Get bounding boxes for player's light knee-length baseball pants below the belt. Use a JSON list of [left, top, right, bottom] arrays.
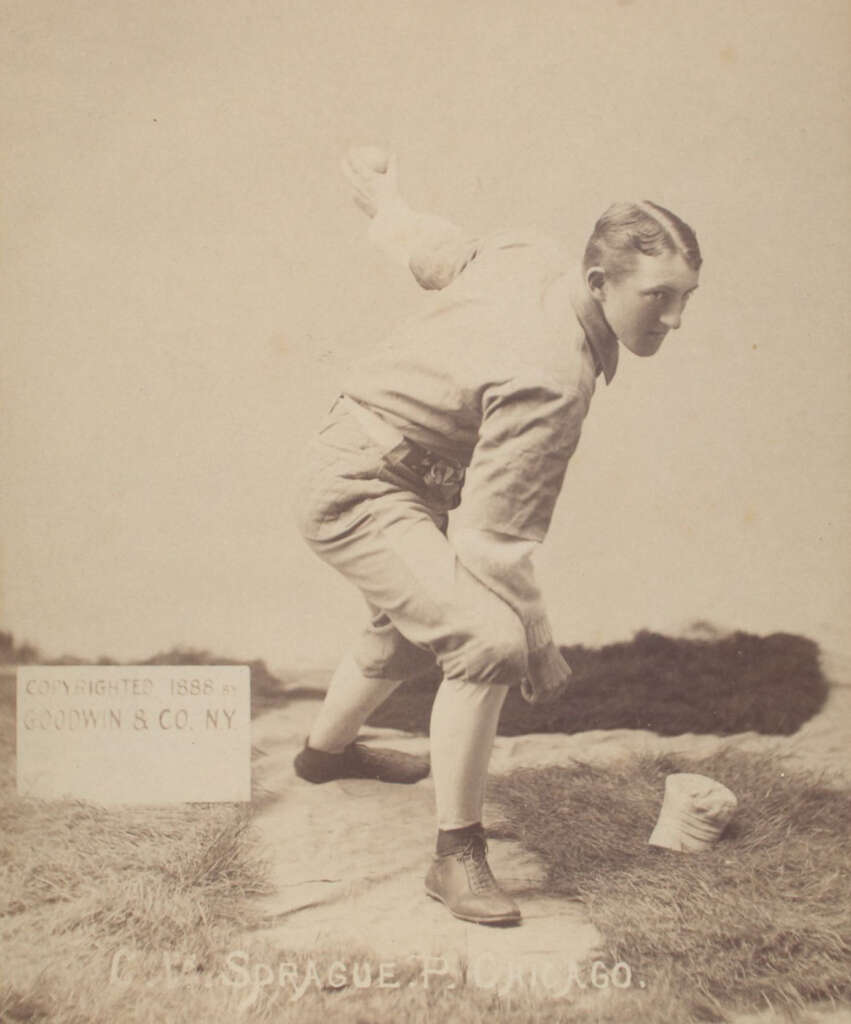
[[294, 402, 526, 686]]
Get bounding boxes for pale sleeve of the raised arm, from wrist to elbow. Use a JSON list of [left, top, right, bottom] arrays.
[[368, 199, 476, 290]]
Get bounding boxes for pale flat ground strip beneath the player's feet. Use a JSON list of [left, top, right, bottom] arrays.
[[242, 701, 600, 992]]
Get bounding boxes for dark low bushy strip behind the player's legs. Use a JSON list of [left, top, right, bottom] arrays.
[[370, 631, 827, 736]]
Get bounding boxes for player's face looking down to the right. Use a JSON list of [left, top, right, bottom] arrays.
[[588, 252, 699, 355]]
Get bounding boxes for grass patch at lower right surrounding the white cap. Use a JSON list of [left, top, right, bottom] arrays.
[[491, 752, 851, 1020]]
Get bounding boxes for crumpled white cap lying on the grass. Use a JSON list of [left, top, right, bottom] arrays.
[[647, 772, 738, 853]]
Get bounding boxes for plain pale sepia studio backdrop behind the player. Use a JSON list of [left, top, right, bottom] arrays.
[[0, 0, 851, 667]]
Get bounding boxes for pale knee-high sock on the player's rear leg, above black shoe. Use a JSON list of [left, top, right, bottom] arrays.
[[307, 654, 399, 754]]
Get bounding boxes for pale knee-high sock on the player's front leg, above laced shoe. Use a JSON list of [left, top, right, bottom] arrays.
[[431, 679, 508, 829]]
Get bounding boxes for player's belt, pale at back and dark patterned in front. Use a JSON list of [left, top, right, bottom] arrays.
[[337, 394, 466, 508]]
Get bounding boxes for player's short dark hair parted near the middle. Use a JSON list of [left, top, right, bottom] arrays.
[[583, 200, 703, 279]]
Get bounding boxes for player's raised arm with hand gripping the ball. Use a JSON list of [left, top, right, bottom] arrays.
[[342, 146, 476, 290]]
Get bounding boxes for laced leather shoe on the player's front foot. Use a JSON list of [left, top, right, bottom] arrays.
[[425, 835, 520, 925]]
